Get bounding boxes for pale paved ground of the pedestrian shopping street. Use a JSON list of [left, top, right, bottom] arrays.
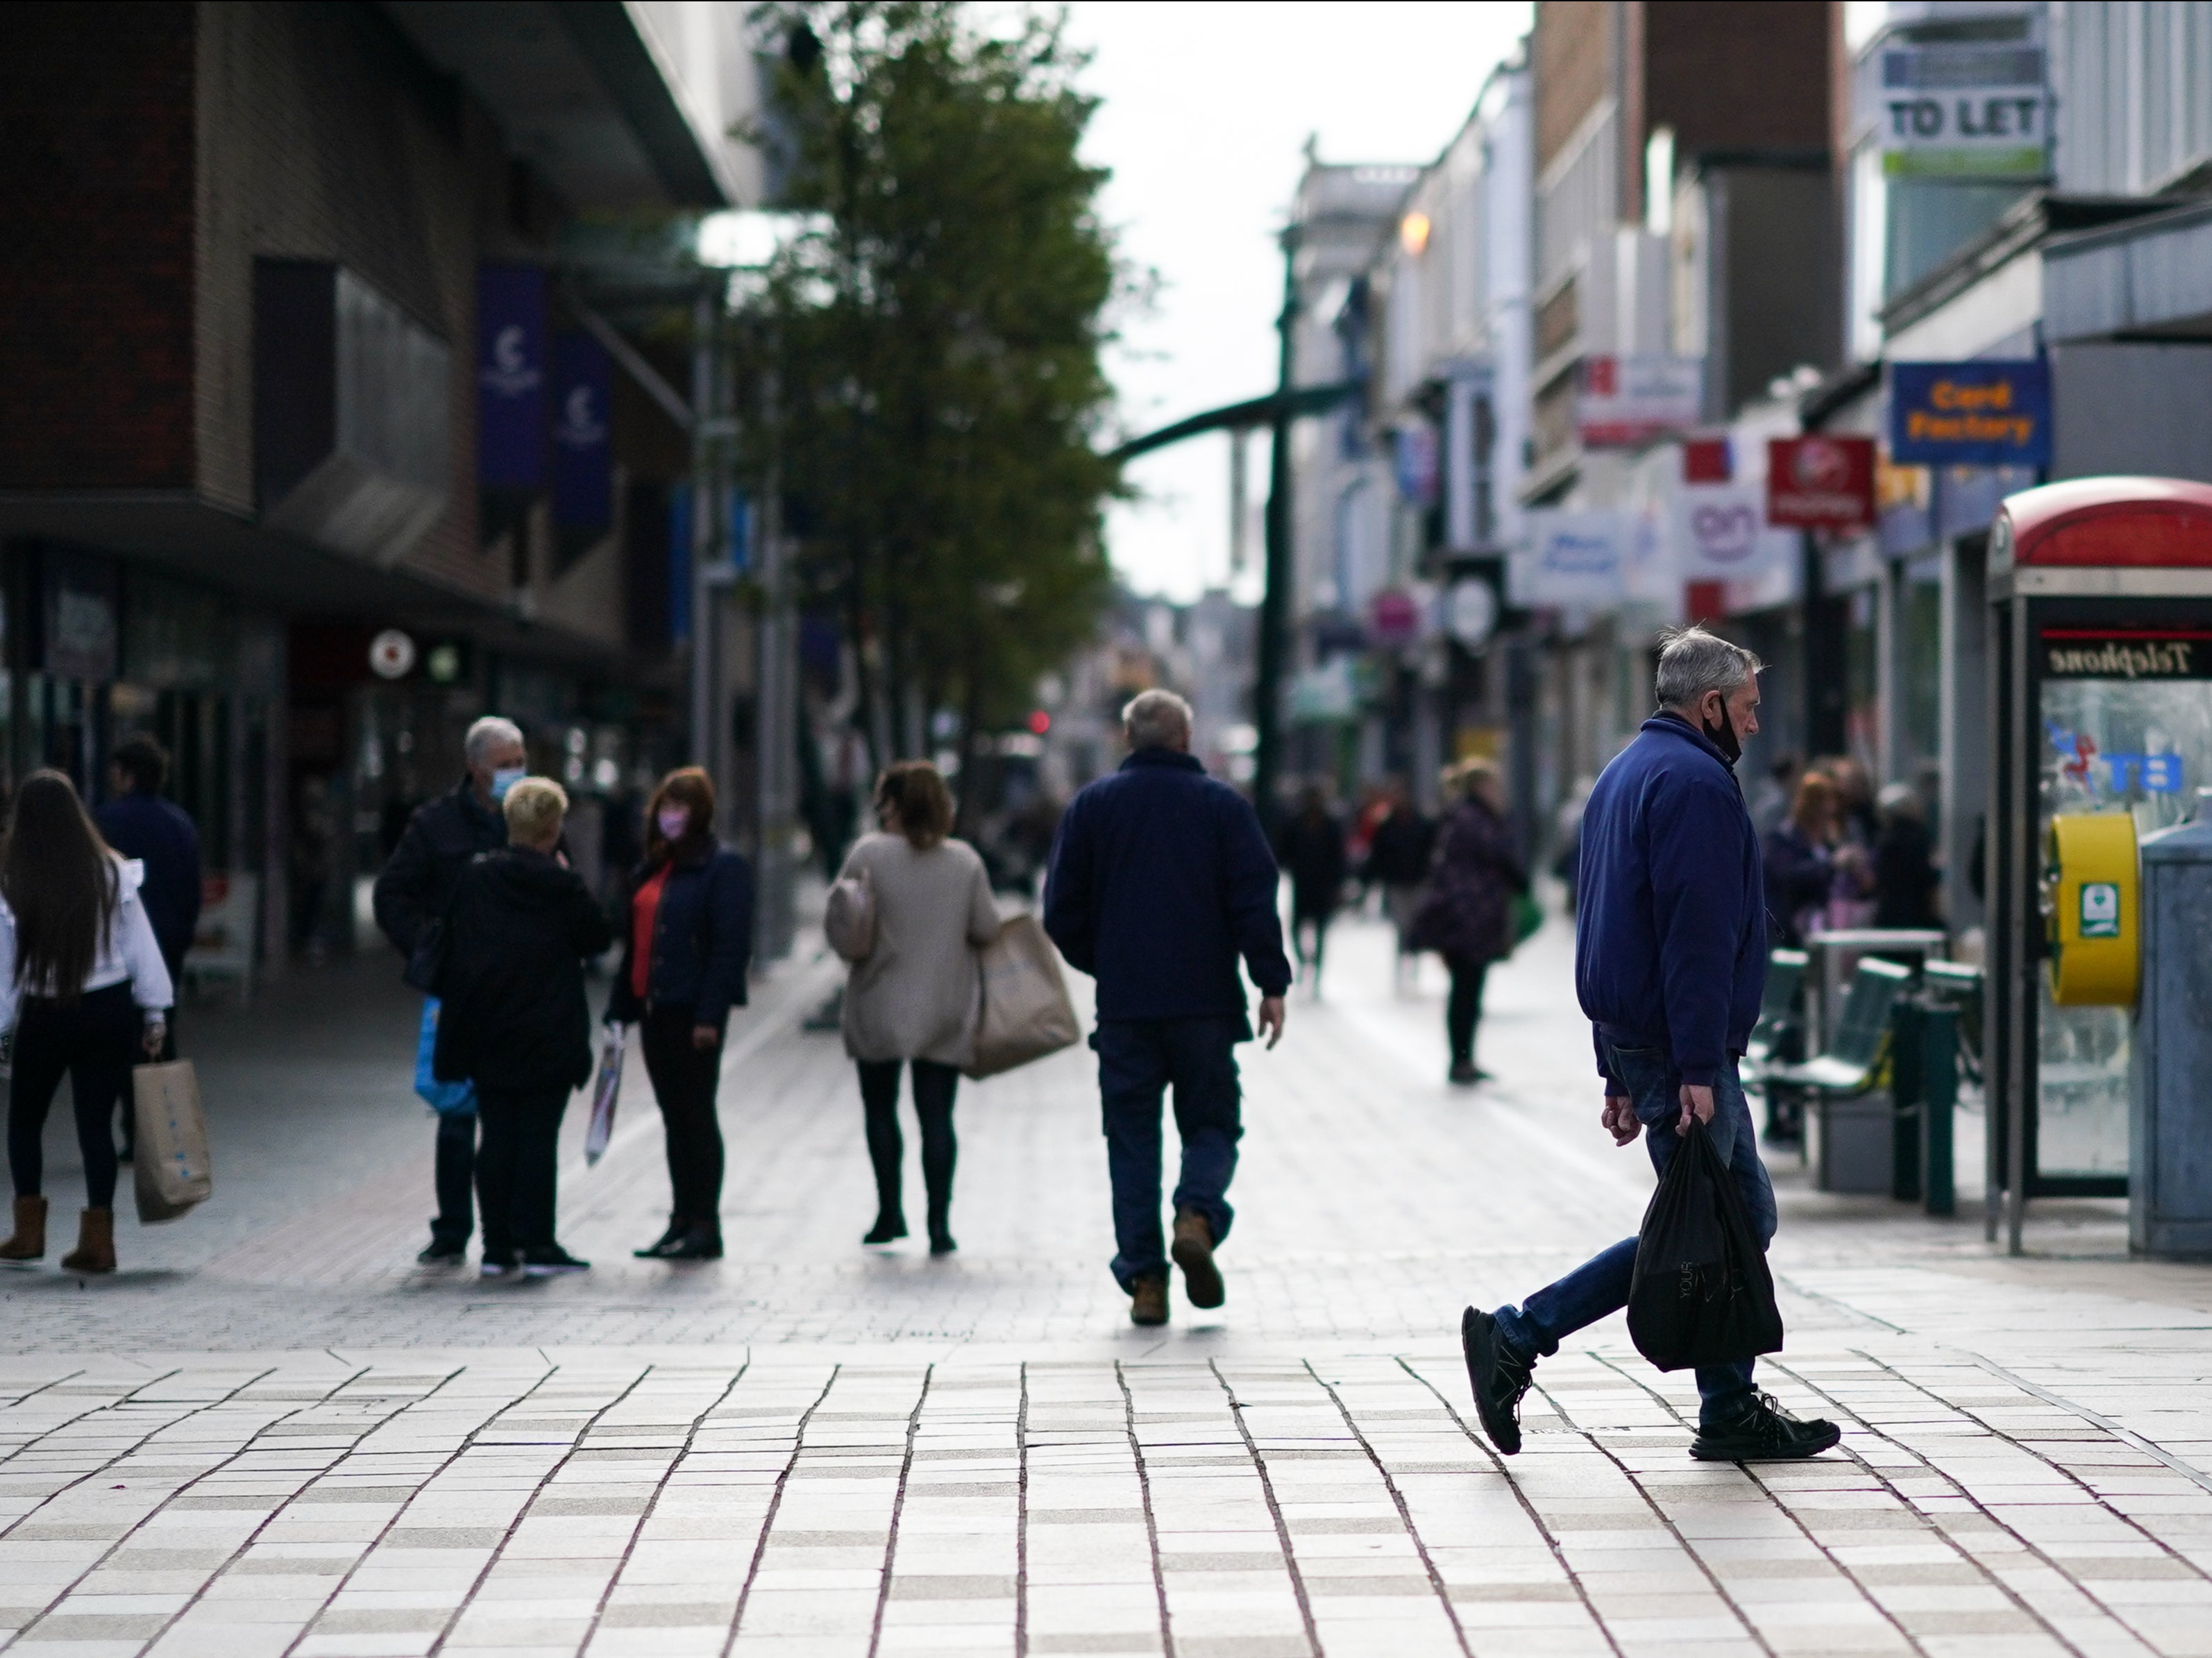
[[0, 922, 2212, 1658]]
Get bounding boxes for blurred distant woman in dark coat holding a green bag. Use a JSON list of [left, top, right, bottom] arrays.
[[1413, 761, 1528, 1088]]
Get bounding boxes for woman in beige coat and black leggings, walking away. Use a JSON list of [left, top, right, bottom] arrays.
[[841, 761, 997, 1255]]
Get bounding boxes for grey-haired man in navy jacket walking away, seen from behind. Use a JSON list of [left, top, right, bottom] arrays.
[[1044, 690, 1290, 1324]]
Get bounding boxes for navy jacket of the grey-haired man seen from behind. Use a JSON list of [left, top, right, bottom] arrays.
[[1044, 747, 1290, 1035]]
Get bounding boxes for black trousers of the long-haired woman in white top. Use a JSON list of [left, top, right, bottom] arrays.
[[7, 981, 144, 1209]]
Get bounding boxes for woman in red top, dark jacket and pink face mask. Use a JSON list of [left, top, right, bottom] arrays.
[[606, 765, 752, 1260]]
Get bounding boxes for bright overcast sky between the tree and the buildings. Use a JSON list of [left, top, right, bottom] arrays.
[[1068, 0, 1882, 599]]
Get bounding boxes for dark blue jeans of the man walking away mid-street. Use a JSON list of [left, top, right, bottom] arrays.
[[1090, 1019, 1252, 1289]]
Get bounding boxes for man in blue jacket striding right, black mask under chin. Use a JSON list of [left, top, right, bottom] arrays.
[[1460, 628, 1841, 1462]]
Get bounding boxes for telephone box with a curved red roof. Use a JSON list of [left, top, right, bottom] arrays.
[[1984, 477, 2212, 1253]]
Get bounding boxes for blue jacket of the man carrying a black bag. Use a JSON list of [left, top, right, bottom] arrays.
[[1575, 714, 1767, 1092]]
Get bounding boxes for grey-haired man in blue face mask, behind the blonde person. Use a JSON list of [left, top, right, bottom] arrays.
[[376, 714, 529, 1264]]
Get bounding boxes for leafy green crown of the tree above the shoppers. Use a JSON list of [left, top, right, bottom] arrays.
[[743, 0, 1128, 807]]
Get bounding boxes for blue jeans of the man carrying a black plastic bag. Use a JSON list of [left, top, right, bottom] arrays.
[[1498, 1037, 1774, 1428]]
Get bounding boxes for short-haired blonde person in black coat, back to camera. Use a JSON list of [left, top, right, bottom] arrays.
[[431, 778, 613, 1278]]
